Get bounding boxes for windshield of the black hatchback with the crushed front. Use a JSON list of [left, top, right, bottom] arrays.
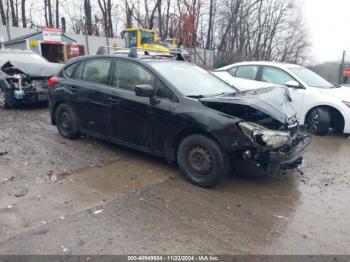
[[150, 62, 236, 97]]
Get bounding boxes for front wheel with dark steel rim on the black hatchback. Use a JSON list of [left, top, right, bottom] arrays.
[[177, 135, 229, 188]]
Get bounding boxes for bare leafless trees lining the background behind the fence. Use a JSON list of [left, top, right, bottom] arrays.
[[0, 0, 309, 63]]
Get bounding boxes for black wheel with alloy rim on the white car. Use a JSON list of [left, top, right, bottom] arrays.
[[306, 107, 331, 136]]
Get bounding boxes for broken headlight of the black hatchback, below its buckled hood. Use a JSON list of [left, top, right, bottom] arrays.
[[239, 122, 292, 149]]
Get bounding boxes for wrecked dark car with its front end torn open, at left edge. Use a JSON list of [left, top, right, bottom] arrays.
[[0, 50, 63, 109]]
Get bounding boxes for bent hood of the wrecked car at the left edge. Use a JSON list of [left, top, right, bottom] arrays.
[[1, 61, 63, 77]]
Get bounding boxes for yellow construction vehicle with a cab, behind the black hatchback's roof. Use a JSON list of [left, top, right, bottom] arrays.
[[121, 28, 170, 53]]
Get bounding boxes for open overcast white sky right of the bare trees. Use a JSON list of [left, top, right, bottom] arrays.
[[304, 0, 350, 62]]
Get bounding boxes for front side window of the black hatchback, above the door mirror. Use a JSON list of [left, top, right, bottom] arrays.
[[113, 60, 154, 91]]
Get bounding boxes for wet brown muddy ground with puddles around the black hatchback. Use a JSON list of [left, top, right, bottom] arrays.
[[0, 107, 350, 254]]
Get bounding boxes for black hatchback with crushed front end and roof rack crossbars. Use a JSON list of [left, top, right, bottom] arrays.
[[49, 55, 310, 187]]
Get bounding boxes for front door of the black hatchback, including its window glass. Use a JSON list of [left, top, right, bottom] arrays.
[[111, 59, 178, 151]]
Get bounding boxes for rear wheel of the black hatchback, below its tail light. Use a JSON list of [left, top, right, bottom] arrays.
[[55, 104, 80, 139]]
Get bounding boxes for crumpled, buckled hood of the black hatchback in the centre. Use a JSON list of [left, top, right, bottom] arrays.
[[200, 86, 296, 124]]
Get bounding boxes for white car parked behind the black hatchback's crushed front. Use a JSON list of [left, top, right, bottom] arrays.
[[213, 62, 350, 135]]
